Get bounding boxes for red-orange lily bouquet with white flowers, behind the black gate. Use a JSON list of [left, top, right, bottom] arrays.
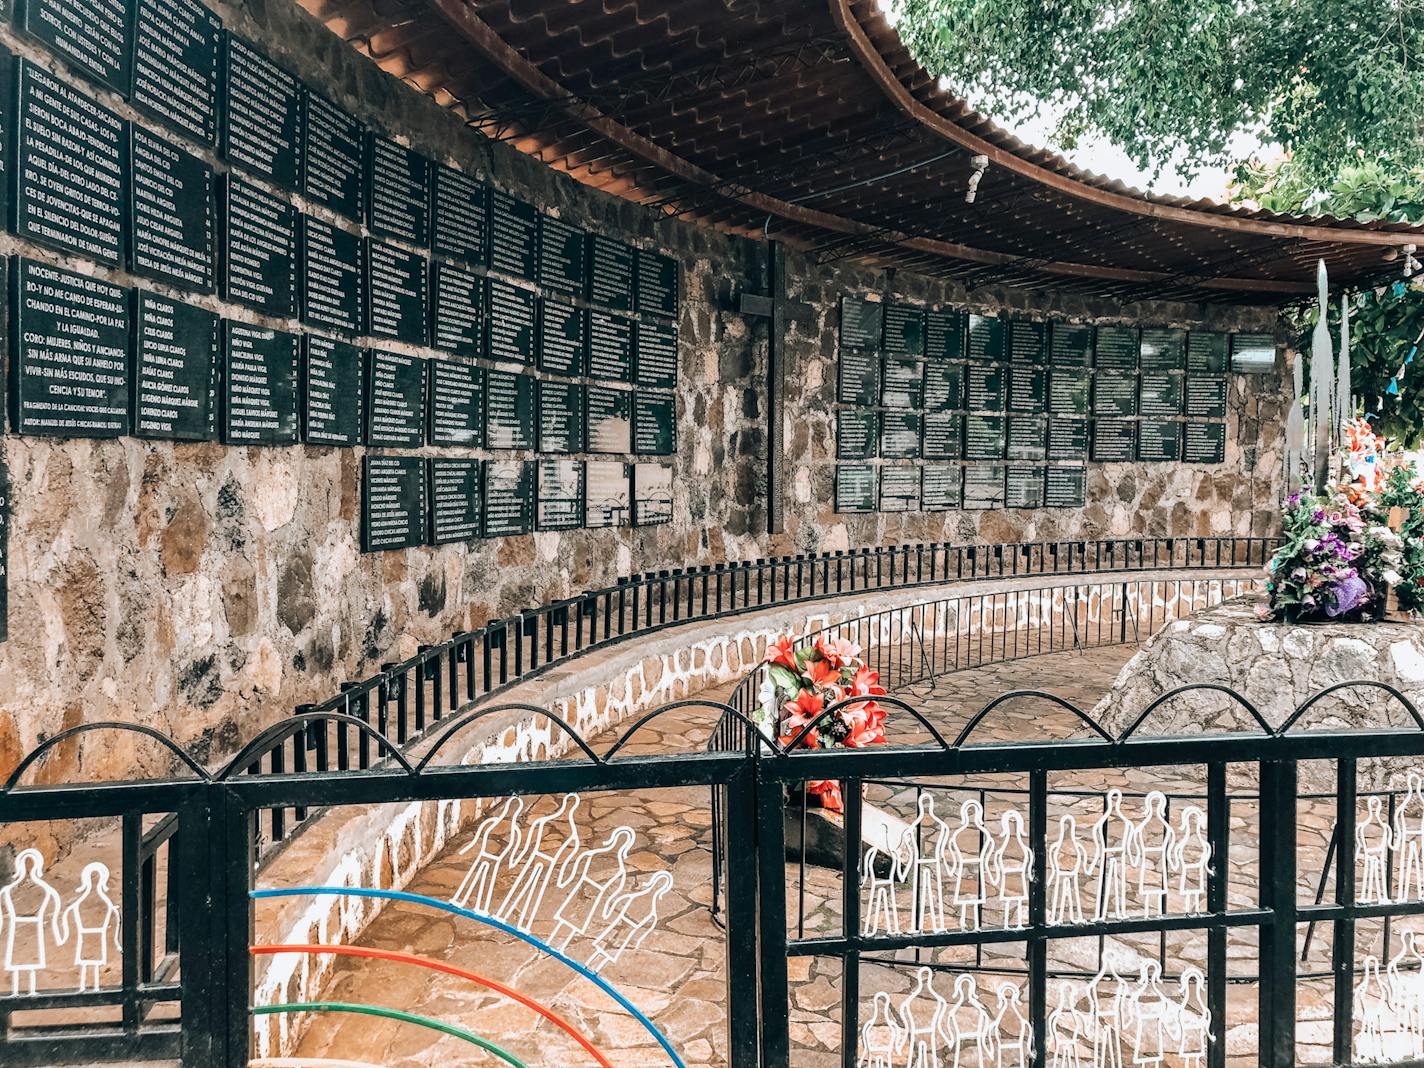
[[760, 634, 886, 812]]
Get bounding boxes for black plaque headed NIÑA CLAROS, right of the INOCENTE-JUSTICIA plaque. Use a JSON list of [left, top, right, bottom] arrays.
[[132, 290, 221, 441]]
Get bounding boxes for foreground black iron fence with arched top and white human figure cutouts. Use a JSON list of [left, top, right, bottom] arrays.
[[0, 684, 1424, 1068]]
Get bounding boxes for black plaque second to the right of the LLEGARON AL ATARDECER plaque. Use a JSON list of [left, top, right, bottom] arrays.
[[219, 174, 296, 319]]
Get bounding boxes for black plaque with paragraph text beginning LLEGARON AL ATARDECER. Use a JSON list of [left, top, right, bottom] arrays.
[[16, 60, 124, 265]]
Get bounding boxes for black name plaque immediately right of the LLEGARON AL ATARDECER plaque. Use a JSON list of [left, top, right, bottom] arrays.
[[128, 124, 216, 293]]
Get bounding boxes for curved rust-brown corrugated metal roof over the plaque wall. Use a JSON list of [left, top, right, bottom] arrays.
[[300, 0, 1424, 303]]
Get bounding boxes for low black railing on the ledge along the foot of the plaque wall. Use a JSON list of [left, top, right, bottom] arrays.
[[235, 537, 1277, 854]]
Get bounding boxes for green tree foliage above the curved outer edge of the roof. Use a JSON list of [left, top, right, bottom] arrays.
[[894, 0, 1424, 185]]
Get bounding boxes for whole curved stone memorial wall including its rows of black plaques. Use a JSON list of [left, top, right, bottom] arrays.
[[0, 0, 1283, 778]]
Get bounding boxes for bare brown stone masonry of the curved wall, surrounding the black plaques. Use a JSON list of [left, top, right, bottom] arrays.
[[0, 0, 1283, 797]]
